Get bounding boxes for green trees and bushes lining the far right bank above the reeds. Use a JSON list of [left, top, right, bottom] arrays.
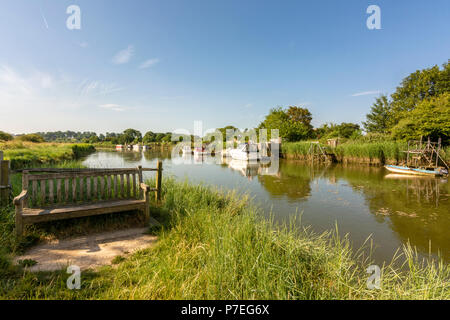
[[258, 62, 450, 143]]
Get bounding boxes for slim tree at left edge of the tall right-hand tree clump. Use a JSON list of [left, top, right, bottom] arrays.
[[363, 95, 392, 133]]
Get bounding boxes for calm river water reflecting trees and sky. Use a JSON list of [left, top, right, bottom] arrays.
[[84, 151, 450, 262]]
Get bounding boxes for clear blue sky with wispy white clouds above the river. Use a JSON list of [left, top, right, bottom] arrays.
[[0, 0, 450, 133]]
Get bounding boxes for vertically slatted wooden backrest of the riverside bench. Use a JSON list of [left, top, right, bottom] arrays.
[[22, 167, 143, 207]]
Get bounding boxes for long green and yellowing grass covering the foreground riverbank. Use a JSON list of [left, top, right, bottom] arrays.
[[0, 180, 450, 299]]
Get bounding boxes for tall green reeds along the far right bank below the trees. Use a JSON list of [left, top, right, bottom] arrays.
[[282, 140, 450, 165]]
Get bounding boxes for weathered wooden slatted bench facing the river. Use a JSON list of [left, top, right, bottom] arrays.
[[14, 161, 162, 236]]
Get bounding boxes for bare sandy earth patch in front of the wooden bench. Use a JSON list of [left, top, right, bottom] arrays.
[[14, 219, 157, 271]]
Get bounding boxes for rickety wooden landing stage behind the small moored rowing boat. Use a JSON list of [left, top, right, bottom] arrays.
[[403, 138, 449, 170]]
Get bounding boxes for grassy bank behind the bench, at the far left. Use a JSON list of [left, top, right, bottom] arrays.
[[0, 141, 95, 169]]
